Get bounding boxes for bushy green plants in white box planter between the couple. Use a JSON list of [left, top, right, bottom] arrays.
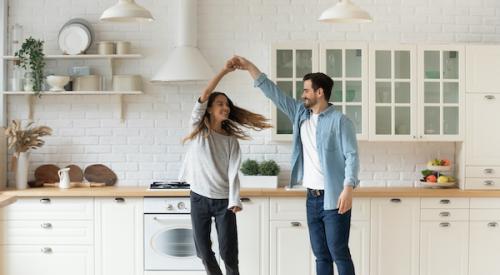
[[240, 159, 280, 188]]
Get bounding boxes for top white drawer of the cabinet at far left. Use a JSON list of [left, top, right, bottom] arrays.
[[0, 197, 94, 220]]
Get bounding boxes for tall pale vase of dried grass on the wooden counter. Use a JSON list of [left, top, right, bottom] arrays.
[[5, 120, 52, 189]]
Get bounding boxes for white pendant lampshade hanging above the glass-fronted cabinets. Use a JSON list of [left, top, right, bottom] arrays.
[[318, 0, 373, 23]]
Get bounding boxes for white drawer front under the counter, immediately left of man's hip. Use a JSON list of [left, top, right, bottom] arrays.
[[269, 198, 307, 220]]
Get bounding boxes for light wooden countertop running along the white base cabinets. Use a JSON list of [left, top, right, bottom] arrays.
[[0, 186, 500, 198]]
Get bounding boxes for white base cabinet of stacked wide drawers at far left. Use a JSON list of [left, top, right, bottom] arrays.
[[0, 197, 94, 275]]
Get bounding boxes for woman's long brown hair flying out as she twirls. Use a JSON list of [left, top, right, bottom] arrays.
[[182, 92, 272, 142]]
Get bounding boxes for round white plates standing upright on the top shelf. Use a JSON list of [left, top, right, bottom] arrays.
[[57, 18, 94, 55]]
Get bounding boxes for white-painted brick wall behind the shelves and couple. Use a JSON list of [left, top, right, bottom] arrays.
[[4, 0, 500, 186]]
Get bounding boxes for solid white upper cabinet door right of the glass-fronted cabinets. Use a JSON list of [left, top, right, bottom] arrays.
[[466, 45, 500, 93]]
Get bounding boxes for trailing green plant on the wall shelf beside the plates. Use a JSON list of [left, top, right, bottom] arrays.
[[15, 36, 45, 96]]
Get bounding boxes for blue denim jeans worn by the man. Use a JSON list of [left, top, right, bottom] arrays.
[[306, 189, 354, 275]]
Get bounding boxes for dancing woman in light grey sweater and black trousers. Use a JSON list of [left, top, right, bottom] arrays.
[[181, 61, 271, 275]]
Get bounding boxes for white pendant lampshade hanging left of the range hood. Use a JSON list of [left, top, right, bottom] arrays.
[[99, 0, 154, 22]]
